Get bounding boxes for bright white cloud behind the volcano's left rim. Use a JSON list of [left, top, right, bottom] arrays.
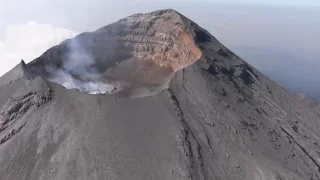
[[0, 21, 77, 76]]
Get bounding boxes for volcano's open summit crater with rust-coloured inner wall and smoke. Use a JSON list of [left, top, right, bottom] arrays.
[[29, 10, 202, 97]]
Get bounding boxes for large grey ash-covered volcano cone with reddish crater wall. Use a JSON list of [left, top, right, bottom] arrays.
[[0, 10, 320, 180]]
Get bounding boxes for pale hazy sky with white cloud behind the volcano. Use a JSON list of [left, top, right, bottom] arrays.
[[0, 0, 320, 98]]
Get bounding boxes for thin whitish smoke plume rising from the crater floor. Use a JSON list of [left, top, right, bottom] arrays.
[[46, 35, 118, 94]]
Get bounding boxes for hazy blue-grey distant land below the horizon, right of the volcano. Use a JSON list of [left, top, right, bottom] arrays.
[[231, 46, 320, 101]]
